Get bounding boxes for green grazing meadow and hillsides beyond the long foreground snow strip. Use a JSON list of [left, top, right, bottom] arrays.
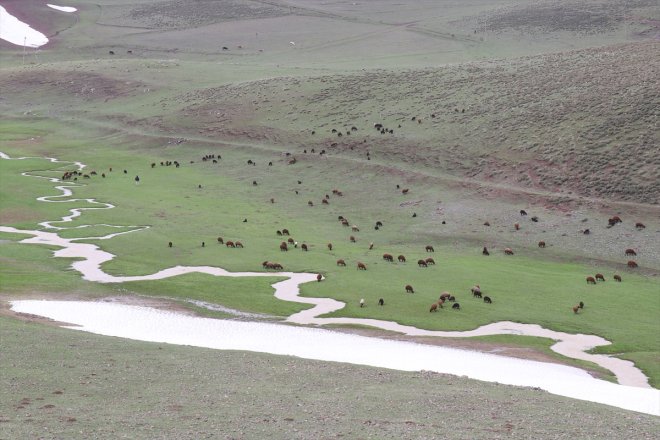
[[0, 0, 660, 438]]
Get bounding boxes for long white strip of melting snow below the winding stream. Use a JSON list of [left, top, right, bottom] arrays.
[[11, 300, 660, 415]]
